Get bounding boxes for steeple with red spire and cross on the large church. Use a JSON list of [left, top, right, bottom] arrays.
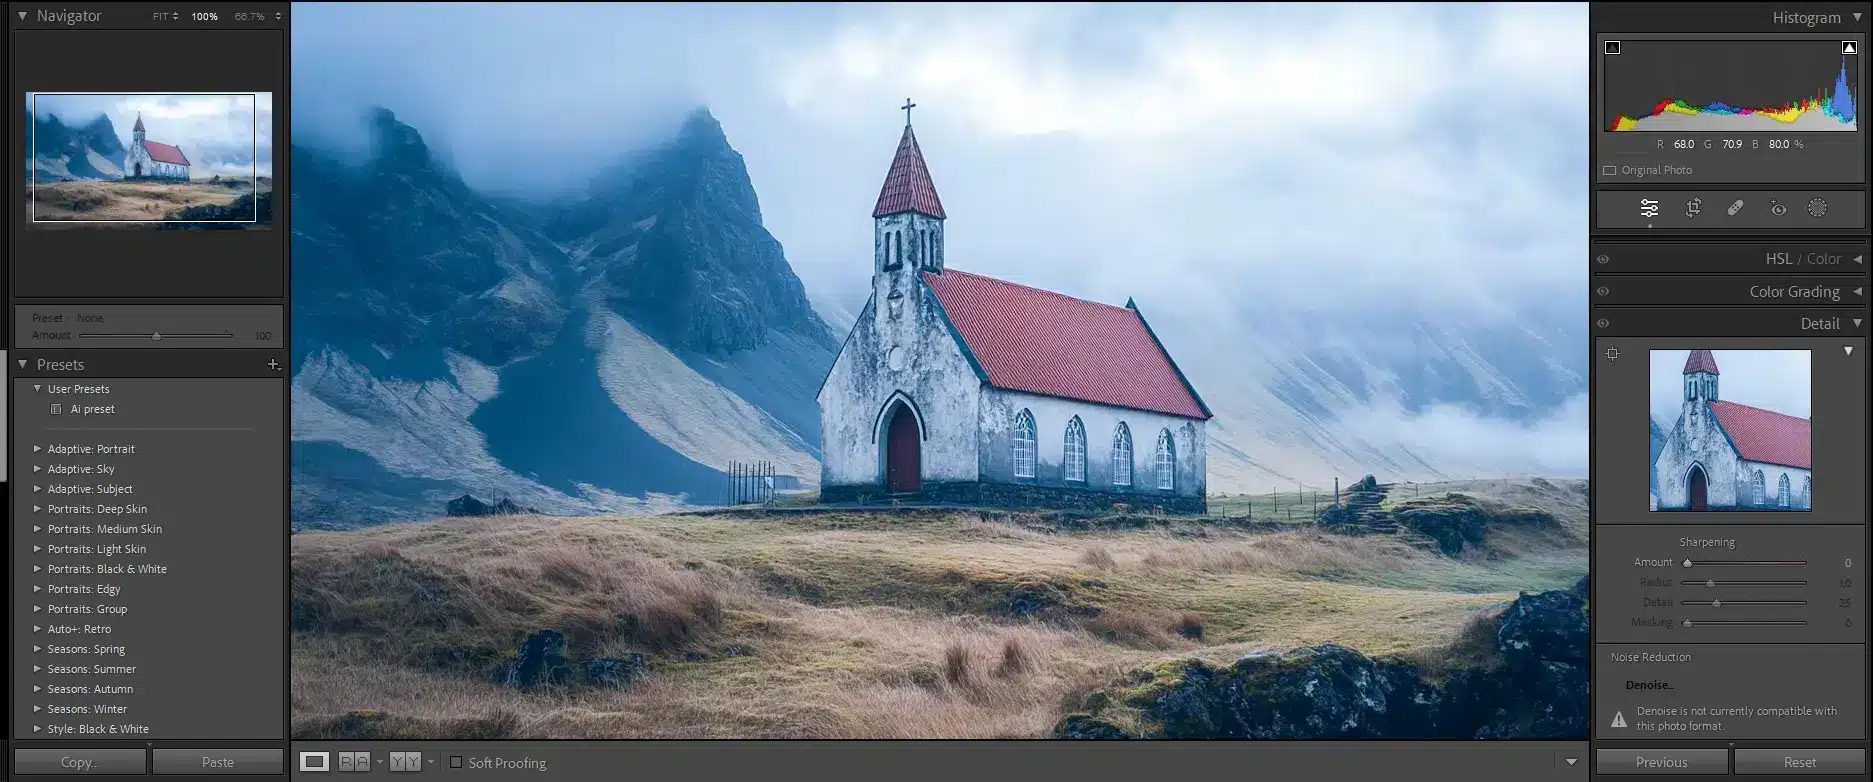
[[871, 99, 946, 273]]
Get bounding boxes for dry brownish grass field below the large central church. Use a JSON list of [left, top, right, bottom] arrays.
[[292, 477, 1586, 739]]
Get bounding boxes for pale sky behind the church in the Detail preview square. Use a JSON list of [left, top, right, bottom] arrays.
[[1652, 350, 1809, 432]]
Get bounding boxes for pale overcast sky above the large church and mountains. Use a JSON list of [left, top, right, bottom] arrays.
[[294, 4, 1586, 311]]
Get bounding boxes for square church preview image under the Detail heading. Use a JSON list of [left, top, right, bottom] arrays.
[[1650, 350, 1815, 511]]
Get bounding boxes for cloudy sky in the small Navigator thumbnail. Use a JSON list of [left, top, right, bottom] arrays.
[[26, 92, 273, 176]]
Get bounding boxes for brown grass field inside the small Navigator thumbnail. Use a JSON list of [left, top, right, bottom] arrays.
[[26, 176, 272, 223]]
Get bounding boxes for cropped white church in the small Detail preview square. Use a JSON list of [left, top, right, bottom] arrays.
[[1654, 350, 1813, 511]]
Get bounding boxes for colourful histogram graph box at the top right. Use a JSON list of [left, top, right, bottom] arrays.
[[1601, 39, 1860, 133]]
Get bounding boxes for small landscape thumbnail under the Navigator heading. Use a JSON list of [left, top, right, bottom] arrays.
[[22, 92, 273, 230]]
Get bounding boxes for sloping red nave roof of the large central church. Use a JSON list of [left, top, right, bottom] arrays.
[[923, 269, 1210, 419]]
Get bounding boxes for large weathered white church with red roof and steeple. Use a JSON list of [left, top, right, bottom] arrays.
[[819, 109, 1210, 513]]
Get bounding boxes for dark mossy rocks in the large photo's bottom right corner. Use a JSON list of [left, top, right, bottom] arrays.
[[1054, 579, 1588, 739]]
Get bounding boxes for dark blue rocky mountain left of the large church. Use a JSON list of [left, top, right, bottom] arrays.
[[292, 110, 835, 526]]
